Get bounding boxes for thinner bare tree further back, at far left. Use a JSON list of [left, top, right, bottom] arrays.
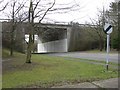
[[3, 0, 26, 56]]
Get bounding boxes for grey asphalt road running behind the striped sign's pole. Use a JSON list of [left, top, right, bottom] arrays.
[[48, 52, 119, 63]]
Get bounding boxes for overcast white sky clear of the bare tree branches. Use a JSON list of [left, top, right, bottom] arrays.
[[0, 0, 114, 23]]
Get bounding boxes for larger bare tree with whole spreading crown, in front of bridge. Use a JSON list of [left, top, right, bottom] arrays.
[[26, 0, 80, 63]]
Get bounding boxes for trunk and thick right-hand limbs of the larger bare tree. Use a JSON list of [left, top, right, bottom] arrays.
[[26, 0, 55, 63]]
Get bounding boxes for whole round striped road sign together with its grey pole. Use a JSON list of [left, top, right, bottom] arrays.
[[104, 23, 112, 71]]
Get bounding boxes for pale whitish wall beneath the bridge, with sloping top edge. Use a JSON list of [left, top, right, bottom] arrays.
[[37, 39, 68, 53]]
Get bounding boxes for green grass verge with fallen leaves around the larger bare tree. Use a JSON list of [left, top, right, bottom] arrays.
[[3, 49, 118, 88]]
